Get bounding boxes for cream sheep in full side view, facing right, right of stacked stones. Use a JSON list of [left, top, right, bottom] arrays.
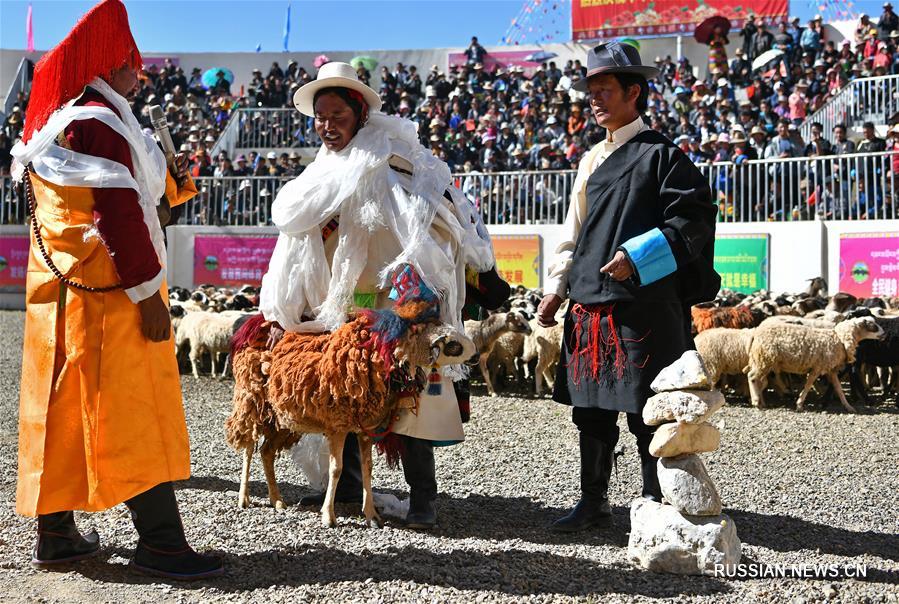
[[745, 317, 883, 413]]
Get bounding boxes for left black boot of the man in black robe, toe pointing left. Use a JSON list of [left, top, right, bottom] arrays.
[[550, 427, 617, 533]]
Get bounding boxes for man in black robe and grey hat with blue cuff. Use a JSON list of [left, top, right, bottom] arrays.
[[538, 42, 720, 532]]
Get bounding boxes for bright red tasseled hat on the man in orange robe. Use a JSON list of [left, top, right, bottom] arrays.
[[22, 0, 143, 142]]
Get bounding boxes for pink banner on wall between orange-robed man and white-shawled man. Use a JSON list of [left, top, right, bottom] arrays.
[[194, 235, 278, 286]]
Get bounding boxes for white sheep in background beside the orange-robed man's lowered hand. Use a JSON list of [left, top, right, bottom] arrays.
[[175, 310, 249, 377]]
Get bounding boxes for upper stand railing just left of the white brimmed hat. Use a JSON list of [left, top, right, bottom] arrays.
[[212, 108, 321, 157]]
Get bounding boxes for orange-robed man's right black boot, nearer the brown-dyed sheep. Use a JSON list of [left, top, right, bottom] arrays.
[[125, 482, 224, 581]]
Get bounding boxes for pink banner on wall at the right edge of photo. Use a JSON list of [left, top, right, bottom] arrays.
[[840, 232, 899, 298]]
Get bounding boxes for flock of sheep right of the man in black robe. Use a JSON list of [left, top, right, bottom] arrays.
[[692, 278, 899, 412]]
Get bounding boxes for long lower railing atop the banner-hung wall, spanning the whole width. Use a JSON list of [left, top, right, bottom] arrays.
[[0, 152, 899, 225]]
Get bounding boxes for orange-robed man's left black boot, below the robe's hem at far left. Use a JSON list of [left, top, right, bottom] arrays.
[[31, 512, 100, 569]]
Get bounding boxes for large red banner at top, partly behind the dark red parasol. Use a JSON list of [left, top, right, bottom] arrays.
[[571, 0, 789, 41]]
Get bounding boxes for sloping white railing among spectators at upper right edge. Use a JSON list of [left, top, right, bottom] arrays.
[[799, 75, 899, 140]]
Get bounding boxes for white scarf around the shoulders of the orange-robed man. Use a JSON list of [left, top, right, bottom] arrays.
[[11, 78, 166, 266]]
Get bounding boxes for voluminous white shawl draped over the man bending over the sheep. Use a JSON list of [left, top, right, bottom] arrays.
[[259, 112, 495, 332]]
